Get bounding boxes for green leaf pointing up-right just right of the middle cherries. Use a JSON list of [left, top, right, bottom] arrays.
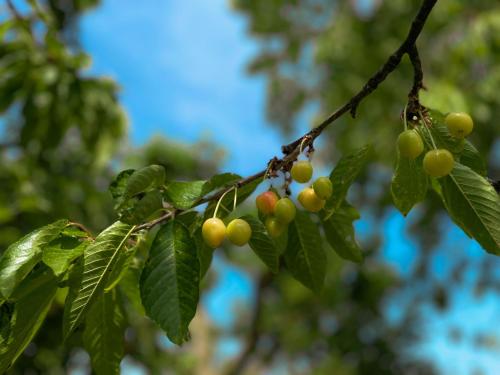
[[325, 145, 371, 211]]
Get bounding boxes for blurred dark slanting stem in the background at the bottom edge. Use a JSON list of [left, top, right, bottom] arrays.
[[227, 272, 273, 375]]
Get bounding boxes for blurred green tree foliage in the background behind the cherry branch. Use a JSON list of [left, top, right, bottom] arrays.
[[0, 0, 500, 374]]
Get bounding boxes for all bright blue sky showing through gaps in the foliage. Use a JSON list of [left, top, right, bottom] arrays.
[[76, 0, 500, 375]]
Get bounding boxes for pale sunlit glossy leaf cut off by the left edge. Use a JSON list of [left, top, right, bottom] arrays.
[[0, 220, 68, 299]]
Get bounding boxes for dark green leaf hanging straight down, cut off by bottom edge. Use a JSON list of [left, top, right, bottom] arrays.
[[83, 290, 126, 375]]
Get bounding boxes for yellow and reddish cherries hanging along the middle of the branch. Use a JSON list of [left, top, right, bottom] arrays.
[[202, 160, 333, 248]]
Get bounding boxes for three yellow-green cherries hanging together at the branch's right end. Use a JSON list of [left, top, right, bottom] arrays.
[[398, 112, 474, 177]]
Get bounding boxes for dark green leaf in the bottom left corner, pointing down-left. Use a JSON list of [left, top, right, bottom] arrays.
[[0, 267, 59, 374]]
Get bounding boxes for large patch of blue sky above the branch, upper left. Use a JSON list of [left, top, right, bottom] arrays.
[[82, 0, 288, 174]]
